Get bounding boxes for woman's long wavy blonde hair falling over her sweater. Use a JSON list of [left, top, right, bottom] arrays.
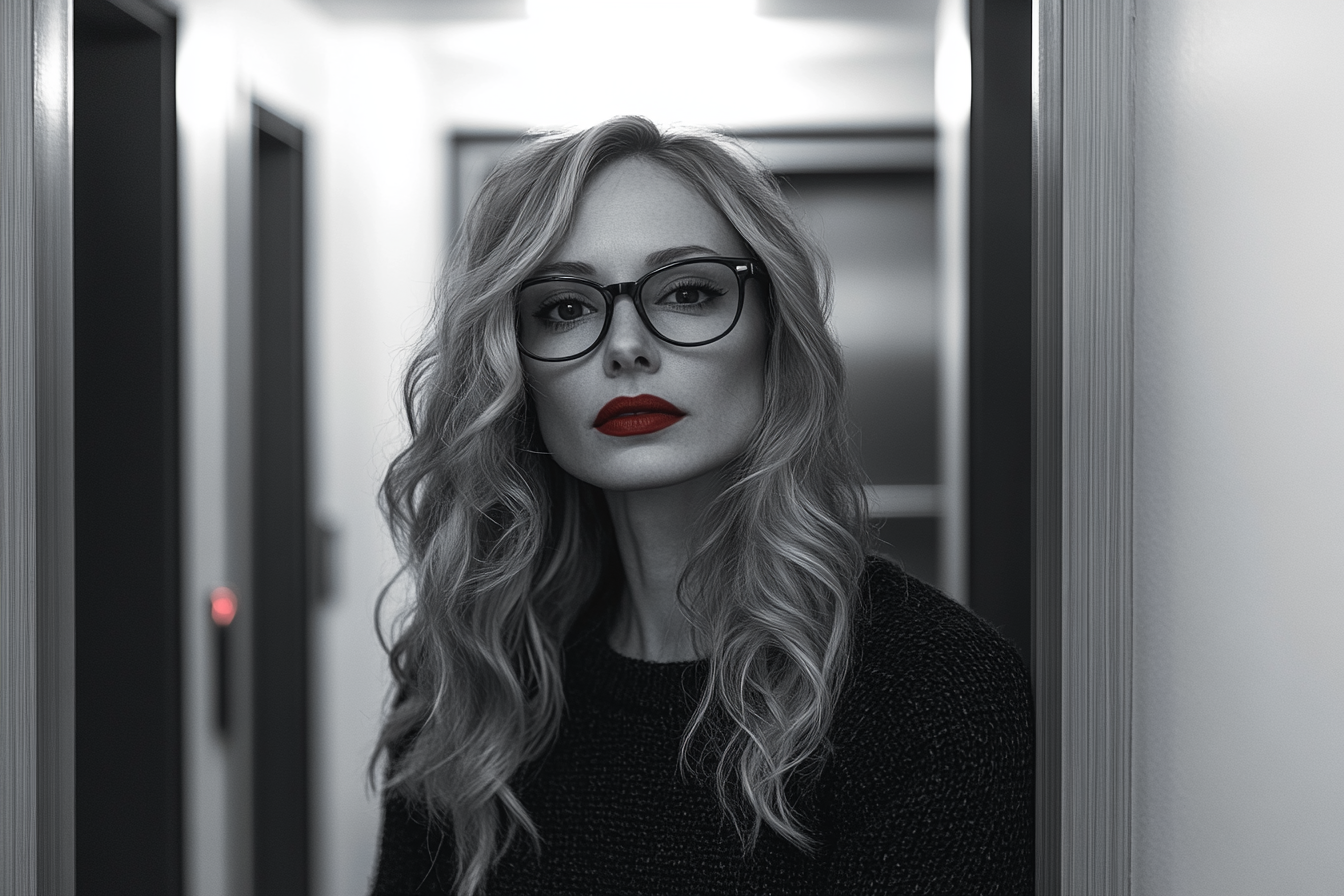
[[374, 117, 868, 896]]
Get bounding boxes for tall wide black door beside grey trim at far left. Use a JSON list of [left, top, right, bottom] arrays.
[[73, 0, 181, 896]]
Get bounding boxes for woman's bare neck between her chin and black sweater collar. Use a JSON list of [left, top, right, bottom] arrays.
[[605, 473, 722, 662]]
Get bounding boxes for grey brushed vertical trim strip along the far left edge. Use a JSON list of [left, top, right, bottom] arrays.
[[0, 0, 75, 895]]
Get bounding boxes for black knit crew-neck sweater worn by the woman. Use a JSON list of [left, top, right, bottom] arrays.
[[374, 559, 1032, 896]]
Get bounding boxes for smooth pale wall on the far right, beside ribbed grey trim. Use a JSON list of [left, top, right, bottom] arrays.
[[1133, 0, 1344, 896]]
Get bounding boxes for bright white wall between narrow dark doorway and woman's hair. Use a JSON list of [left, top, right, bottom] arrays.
[[310, 26, 446, 896]]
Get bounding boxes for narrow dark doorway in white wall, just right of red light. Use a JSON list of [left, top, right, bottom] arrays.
[[248, 99, 312, 896]]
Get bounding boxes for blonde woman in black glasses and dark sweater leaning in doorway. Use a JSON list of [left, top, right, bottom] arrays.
[[374, 118, 1031, 896]]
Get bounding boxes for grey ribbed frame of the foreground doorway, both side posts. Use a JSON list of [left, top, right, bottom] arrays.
[[0, 0, 1134, 895]]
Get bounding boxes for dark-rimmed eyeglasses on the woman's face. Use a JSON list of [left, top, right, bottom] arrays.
[[515, 255, 767, 361]]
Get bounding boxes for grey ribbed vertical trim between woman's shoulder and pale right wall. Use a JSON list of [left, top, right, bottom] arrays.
[[1032, 0, 1134, 896]]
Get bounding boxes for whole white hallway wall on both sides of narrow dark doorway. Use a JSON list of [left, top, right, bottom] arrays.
[[179, 0, 444, 896]]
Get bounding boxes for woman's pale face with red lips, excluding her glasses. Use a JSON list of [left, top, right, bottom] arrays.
[[523, 159, 766, 492]]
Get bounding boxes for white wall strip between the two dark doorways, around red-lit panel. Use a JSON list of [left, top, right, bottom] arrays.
[[177, 7, 338, 896]]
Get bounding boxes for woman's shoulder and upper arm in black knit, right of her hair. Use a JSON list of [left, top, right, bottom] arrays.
[[821, 557, 1034, 893]]
